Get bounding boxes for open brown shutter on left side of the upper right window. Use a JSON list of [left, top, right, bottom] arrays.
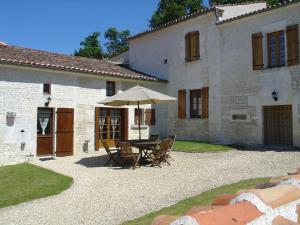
[[252, 33, 264, 70]]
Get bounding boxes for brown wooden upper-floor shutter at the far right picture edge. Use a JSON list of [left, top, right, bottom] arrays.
[[286, 24, 299, 66]]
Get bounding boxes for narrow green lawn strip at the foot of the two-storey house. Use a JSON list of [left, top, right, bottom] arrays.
[[173, 141, 232, 153]]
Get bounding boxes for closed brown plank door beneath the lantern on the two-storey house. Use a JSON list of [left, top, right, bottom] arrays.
[[264, 105, 293, 146]]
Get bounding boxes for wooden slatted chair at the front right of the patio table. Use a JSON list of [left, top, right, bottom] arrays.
[[149, 139, 170, 168]]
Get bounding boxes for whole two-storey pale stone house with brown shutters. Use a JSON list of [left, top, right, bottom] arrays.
[[129, 1, 300, 147]]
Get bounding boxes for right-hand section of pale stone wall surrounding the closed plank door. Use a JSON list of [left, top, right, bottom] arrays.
[[218, 4, 300, 146]]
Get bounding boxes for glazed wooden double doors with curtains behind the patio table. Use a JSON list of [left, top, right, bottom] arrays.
[[95, 108, 128, 150]]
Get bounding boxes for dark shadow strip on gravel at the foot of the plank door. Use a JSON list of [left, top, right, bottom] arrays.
[[228, 145, 300, 152]]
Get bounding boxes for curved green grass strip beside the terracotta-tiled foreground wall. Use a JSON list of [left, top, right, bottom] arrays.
[[122, 178, 270, 225]]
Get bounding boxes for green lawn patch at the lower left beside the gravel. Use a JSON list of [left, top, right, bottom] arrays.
[[0, 163, 73, 208]]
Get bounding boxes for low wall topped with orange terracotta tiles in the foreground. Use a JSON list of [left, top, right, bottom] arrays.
[[152, 168, 300, 225]]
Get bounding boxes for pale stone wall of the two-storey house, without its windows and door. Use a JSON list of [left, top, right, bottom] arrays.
[[129, 3, 300, 146]]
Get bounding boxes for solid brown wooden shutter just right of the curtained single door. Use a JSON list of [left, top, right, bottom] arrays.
[[56, 108, 74, 156]]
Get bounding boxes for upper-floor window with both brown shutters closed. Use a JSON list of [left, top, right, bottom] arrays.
[[185, 31, 200, 62]]
